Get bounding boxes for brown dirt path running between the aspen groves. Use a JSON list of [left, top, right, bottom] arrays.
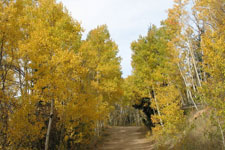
[[96, 127, 153, 150]]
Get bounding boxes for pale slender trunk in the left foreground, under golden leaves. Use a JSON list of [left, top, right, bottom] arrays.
[[45, 99, 55, 150]]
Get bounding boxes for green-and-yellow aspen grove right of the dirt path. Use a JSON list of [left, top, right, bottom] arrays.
[[131, 0, 225, 149]]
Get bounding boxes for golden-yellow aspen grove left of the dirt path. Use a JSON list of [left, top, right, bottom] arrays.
[[0, 0, 122, 150]]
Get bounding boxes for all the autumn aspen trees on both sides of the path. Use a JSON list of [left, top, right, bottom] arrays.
[[0, 0, 225, 150]]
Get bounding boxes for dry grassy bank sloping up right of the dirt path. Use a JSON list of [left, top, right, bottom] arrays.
[[153, 108, 222, 150]]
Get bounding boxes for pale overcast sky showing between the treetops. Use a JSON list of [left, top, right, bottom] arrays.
[[58, 0, 173, 77]]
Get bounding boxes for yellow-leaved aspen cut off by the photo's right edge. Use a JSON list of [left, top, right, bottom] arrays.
[[194, 0, 225, 148]]
